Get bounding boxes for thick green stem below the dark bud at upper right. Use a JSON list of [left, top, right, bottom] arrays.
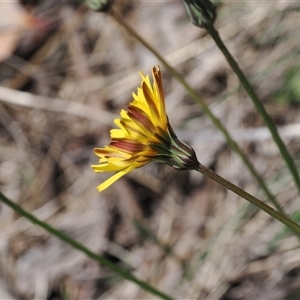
[[205, 24, 300, 200]]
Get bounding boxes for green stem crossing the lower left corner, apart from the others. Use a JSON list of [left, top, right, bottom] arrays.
[[0, 192, 173, 300]]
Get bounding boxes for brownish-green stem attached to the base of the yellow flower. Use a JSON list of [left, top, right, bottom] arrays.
[[197, 163, 300, 237]]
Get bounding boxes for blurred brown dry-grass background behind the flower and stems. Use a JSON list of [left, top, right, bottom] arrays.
[[0, 0, 300, 300]]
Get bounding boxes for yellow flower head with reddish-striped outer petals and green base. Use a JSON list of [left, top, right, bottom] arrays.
[[92, 67, 199, 192]]
